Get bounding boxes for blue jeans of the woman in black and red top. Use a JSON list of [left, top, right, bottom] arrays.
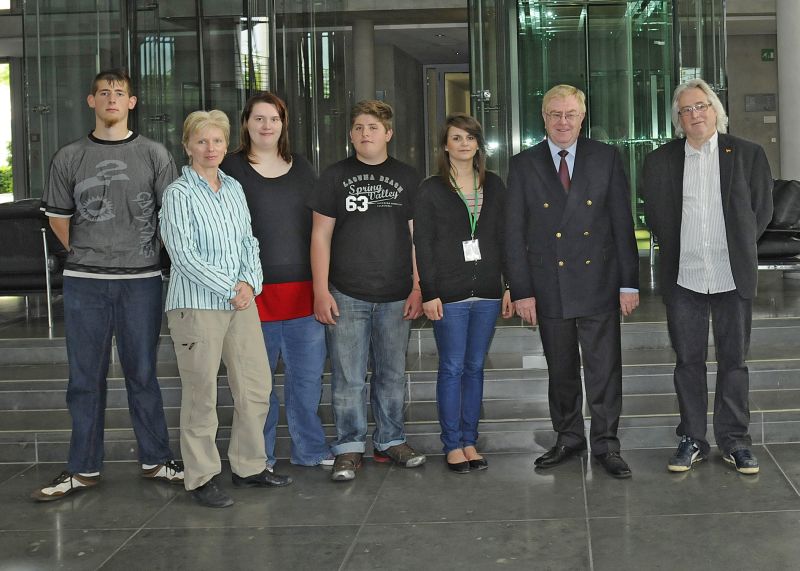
[[261, 315, 331, 466]]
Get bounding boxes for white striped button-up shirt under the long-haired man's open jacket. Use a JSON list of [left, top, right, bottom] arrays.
[[678, 133, 736, 293]]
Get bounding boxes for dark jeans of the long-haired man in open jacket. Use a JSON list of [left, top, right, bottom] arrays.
[[667, 286, 752, 454]]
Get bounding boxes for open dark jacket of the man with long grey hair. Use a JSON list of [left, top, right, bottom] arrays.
[[642, 133, 773, 302]]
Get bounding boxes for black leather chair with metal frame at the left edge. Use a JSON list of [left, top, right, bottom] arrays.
[[0, 198, 67, 329]]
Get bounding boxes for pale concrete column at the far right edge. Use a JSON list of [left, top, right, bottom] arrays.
[[773, 0, 800, 180]]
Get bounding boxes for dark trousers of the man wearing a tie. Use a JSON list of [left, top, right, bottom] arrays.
[[539, 310, 622, 455]]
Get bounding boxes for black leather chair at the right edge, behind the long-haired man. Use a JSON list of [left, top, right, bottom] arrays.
[[758, 180, 800, 270]]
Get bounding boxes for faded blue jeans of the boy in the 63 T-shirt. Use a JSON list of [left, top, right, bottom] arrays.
[[326, 288, 411, 455]]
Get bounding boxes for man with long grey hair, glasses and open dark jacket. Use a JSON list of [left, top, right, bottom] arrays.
[[643, 79, 772, 474]]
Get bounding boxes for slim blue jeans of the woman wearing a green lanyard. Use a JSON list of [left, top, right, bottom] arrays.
[[433, 299, 500, 454]]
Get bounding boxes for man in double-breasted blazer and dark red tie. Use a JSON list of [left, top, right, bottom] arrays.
[[506, 85, 639, 478]]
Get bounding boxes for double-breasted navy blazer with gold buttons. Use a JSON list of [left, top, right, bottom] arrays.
[[506, 137, 639, 319]]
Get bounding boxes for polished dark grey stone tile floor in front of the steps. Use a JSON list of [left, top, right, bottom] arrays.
[[0, 450, 800, 571]]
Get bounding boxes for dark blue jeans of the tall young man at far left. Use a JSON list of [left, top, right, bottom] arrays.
[[64, 277, 173, 473]]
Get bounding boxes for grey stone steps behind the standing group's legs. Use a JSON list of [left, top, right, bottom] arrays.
[[0, 310, 800, 463]]
